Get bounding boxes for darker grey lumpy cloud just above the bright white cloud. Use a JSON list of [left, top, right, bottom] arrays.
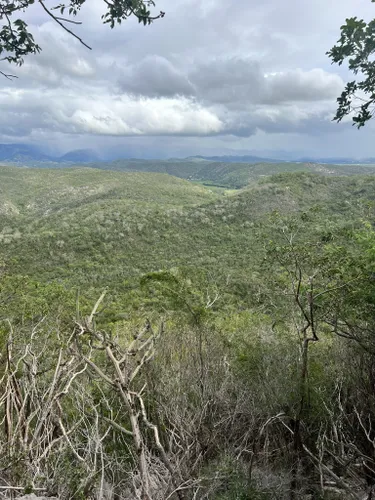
[[119, 55, 344, 108]]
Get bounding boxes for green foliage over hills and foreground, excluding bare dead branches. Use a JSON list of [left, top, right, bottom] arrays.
[[0, 164, 375, 500]]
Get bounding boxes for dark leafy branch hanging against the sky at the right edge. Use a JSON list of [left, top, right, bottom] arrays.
[[327, 0, 375, 128]]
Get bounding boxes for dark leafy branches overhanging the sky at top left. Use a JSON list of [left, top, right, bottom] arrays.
[[0, 0, 165, 79]]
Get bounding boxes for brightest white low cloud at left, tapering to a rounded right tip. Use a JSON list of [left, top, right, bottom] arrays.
[[0, 87, 223, 136]]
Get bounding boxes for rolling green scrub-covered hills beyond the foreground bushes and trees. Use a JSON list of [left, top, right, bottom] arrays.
[[0, 165, 375, 320]]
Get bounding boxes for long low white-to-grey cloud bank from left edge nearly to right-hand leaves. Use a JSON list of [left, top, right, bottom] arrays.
[[0, 75, 338, 137]]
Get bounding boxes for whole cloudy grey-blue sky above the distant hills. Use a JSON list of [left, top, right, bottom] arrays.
[[0, 0, 375, 158]]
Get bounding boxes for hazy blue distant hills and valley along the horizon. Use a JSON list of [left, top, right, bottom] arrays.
[[0, 144, 375, 189]]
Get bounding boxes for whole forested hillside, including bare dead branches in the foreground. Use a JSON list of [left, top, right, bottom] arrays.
[[0, 162, 375, 500]]
